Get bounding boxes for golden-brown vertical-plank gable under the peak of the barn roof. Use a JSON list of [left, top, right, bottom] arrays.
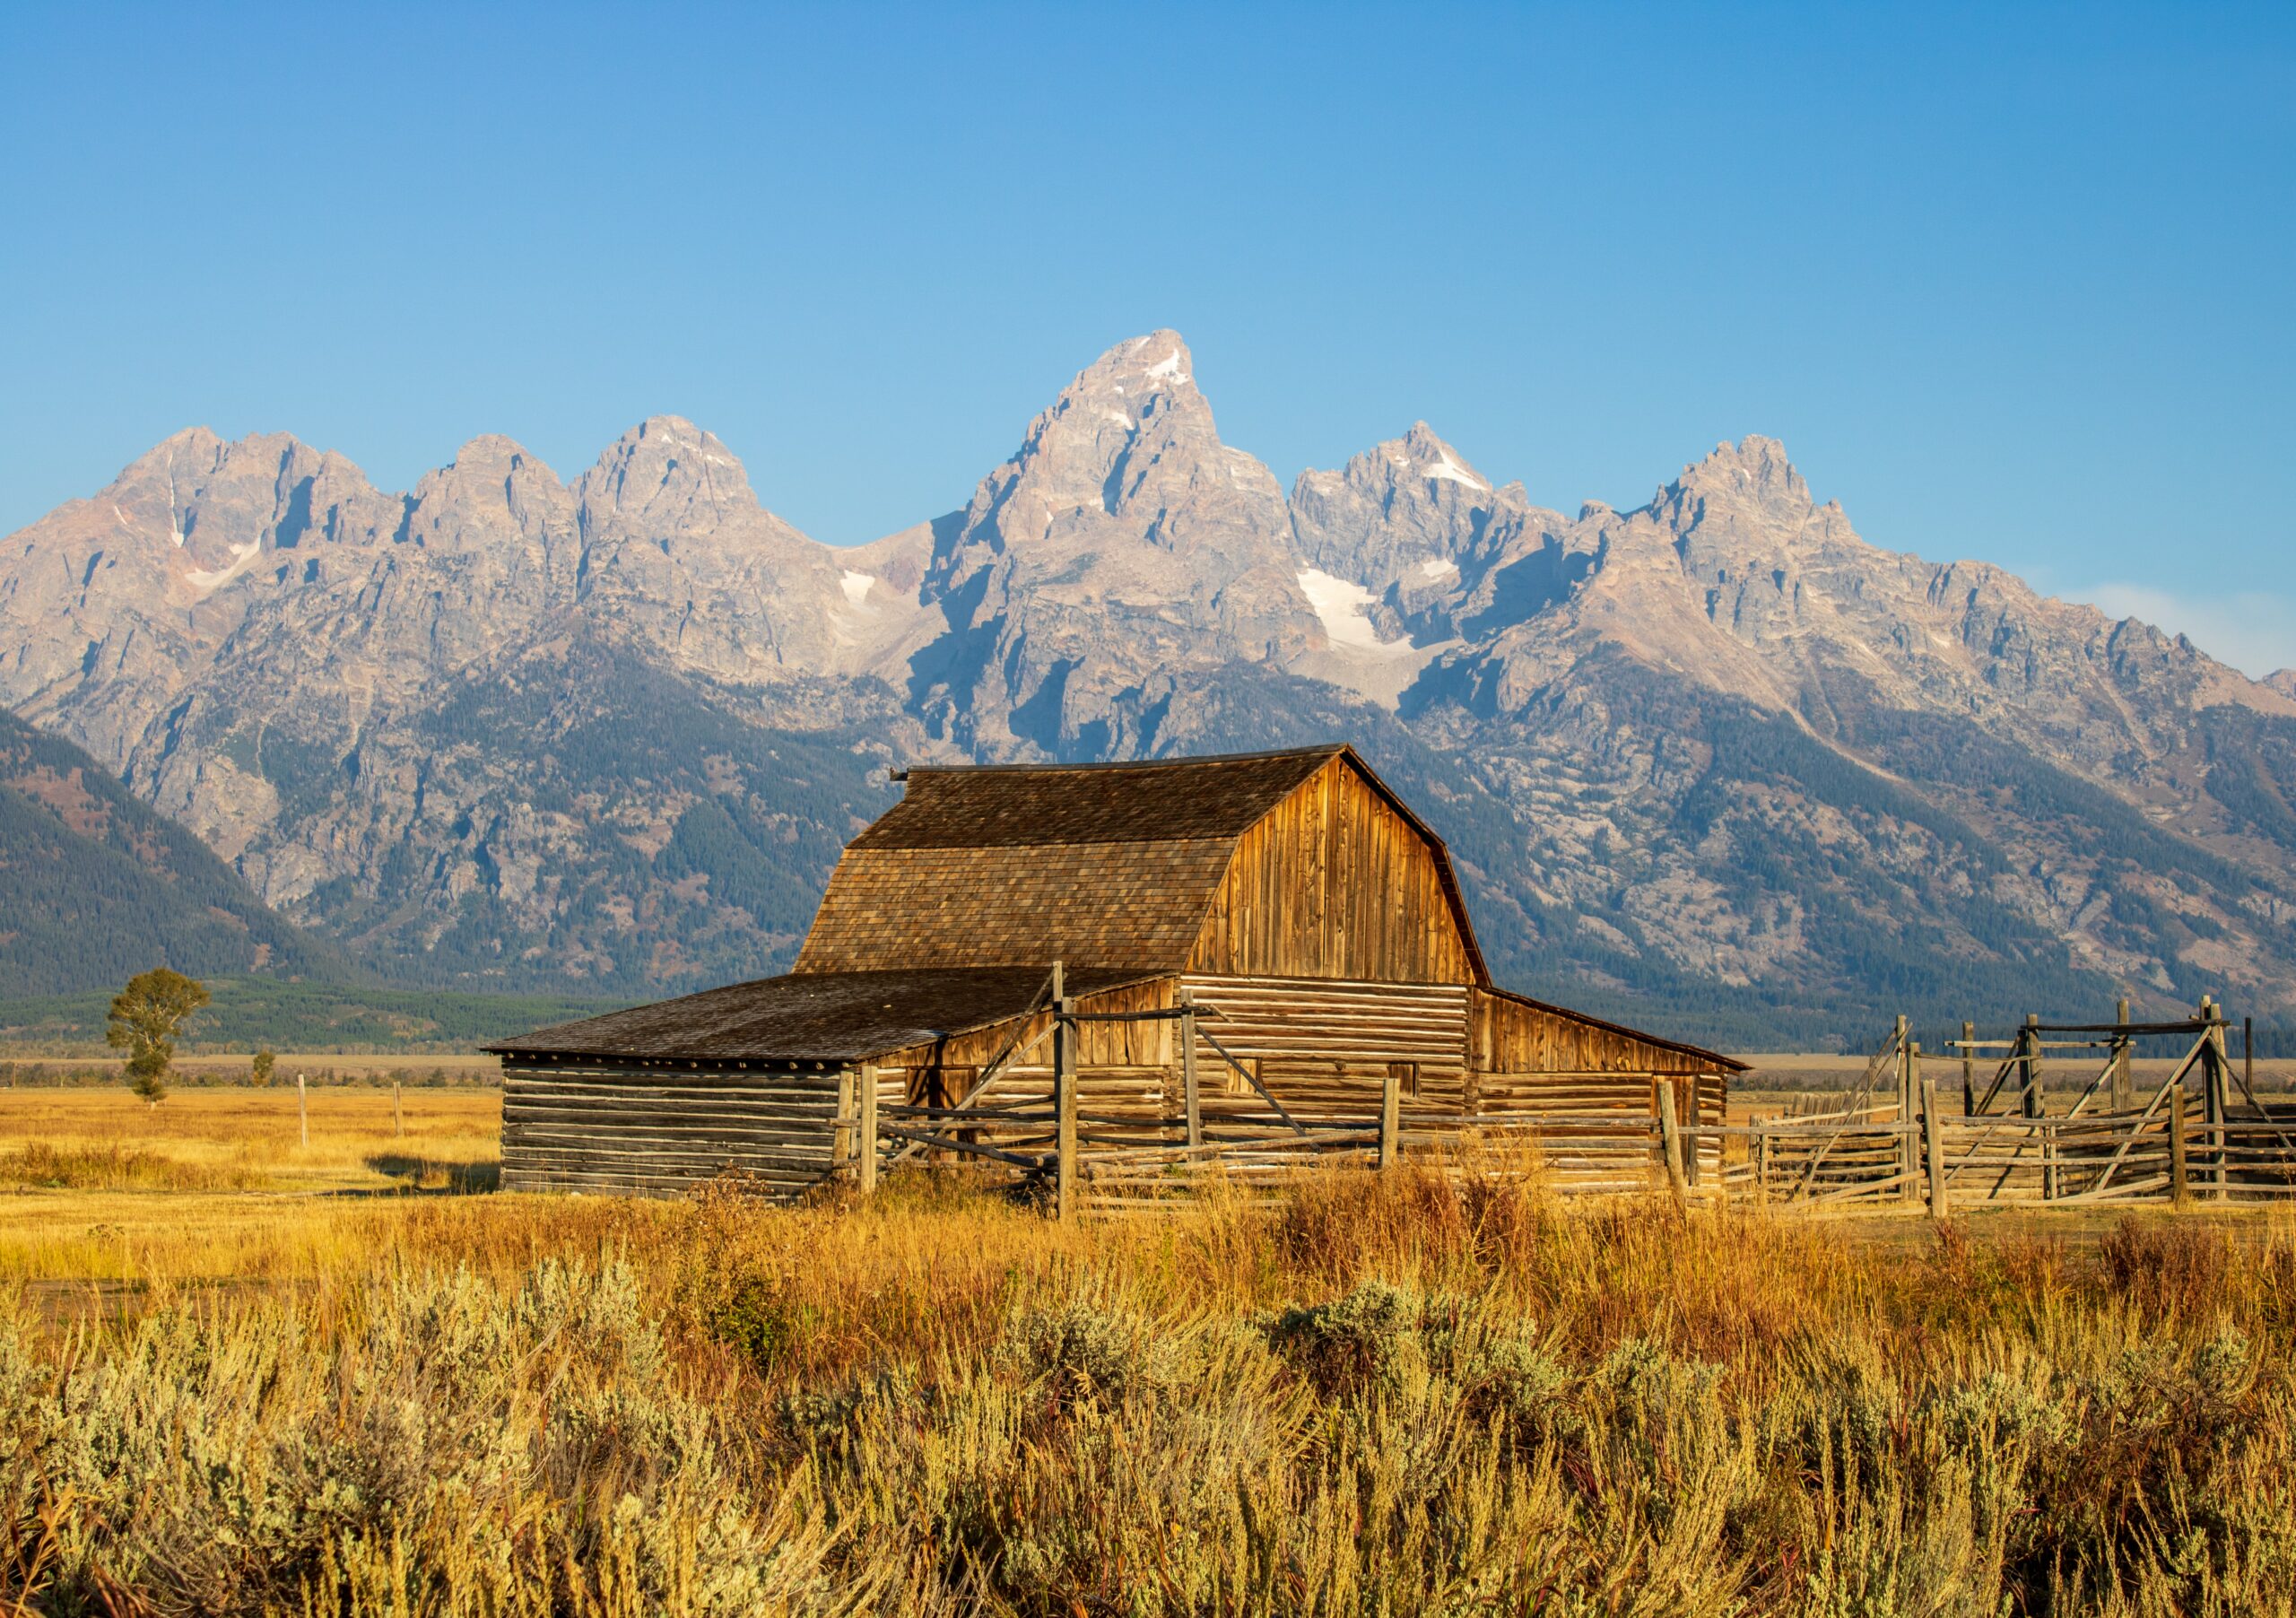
[[1189, 757, 1474, 985]]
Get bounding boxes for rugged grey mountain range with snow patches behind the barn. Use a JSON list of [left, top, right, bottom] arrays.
[[0, 330, 2296, 1044]]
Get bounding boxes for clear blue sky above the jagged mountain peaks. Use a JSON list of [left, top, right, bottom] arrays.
[[0, 3, 2296, 673]]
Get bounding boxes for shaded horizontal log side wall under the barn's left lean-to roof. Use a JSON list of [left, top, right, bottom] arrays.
[[503, 1060, 838, 1196]]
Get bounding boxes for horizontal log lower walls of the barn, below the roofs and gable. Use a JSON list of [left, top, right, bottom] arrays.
[[503, 973, 1725, 1196]]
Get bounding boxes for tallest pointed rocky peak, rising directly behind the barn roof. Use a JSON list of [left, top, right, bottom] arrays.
[[911, 330, 1323, 757]]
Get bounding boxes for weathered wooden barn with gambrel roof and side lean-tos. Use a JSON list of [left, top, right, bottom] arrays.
[[491, 746, 1743, 1194]]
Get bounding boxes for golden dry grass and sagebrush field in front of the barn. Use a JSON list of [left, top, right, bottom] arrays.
[[0, 1085, 2296, 1618]]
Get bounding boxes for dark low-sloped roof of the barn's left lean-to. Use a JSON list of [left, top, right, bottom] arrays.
[[487, 966, 1141, 1063]]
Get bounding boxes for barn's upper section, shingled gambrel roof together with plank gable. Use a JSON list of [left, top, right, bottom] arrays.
[[796, 746, 1488, 985]]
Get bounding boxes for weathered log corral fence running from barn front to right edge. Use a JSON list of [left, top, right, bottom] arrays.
[[824, 982, 2296, 1219]]
